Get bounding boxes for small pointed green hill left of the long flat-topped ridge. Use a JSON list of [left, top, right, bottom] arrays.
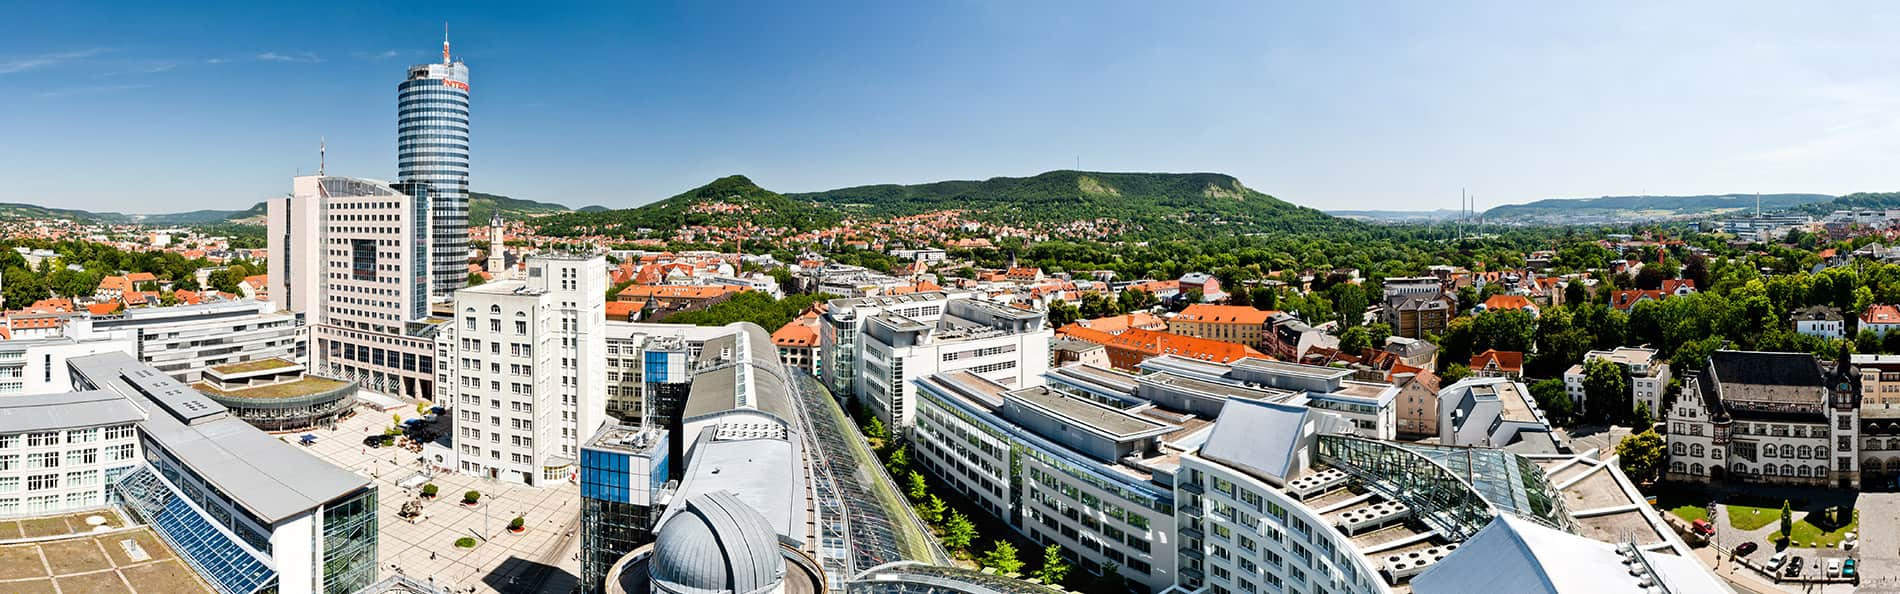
[[536, 175, 840, 237]]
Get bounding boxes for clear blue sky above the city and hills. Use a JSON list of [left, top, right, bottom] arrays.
[[0, 0, 1900, 213]]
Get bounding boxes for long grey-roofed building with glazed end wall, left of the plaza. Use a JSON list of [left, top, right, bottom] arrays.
[[63, 353, 378, 594]]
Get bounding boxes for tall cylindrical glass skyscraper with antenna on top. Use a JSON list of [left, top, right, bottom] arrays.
[[395, 38, 469, 296]]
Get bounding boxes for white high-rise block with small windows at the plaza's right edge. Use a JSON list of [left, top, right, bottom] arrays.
[[445, 254, 608, 486]]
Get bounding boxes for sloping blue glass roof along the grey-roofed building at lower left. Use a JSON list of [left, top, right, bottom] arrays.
[[114, 467, 277, 594]]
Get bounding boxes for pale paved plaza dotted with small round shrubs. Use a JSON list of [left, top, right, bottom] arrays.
[[283, 408, 581, 592]]
